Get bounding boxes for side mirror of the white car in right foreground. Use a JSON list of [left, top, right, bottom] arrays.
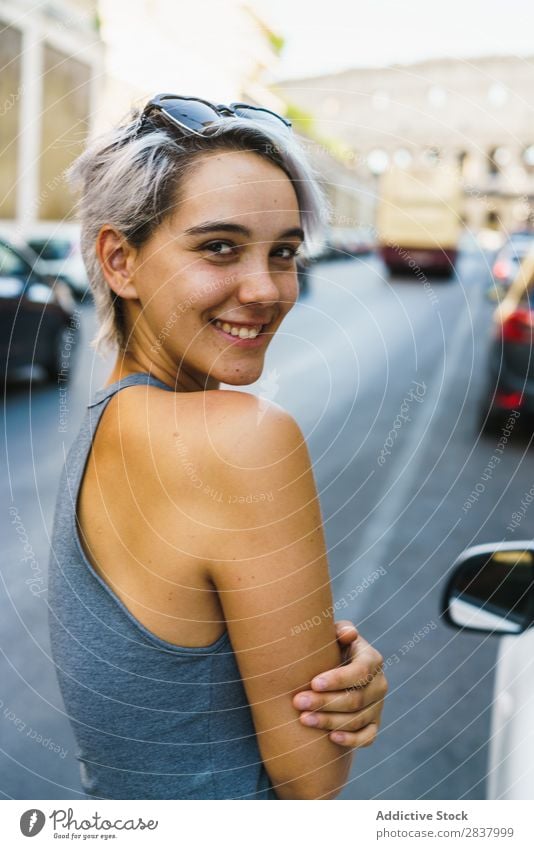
[[441, 540, 534, 634]]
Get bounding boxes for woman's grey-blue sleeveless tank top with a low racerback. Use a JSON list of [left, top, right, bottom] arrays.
[[48, 372, 277, 799]]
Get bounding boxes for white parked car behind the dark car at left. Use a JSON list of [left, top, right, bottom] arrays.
[[26, 223, 90, 300]]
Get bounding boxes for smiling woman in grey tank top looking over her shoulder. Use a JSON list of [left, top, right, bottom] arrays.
[[49, 95, 386, 799]]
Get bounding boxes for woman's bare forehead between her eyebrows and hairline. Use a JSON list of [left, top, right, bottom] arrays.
[[176, 151, 300, 227]]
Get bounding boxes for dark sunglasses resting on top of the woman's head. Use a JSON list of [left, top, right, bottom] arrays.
[[140, 94, 291, 136]]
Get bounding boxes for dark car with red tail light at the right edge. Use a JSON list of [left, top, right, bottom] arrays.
[[480, 250, 534, 430]]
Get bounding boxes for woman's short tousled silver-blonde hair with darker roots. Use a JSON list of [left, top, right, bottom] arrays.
[[67, 104, 331, 353]]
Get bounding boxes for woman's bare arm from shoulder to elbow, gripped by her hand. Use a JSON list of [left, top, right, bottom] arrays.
[[199, 392, 352, 799]]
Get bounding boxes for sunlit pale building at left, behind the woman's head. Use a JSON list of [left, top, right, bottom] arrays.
[[0, 0, 374, 238]]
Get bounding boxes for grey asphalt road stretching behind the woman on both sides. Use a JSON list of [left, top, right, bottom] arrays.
[[0, 243, 534, 799]]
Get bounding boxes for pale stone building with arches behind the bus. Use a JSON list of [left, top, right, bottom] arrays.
[[276, 56, 534, 231]]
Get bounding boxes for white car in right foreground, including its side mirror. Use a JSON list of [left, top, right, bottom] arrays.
[[442, 540, 534, 799]]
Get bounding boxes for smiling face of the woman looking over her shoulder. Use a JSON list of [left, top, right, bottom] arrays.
[[116, 150, 303, 389]]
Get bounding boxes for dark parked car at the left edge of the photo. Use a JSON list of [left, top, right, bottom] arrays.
[[0, 240, 77, 380]]
